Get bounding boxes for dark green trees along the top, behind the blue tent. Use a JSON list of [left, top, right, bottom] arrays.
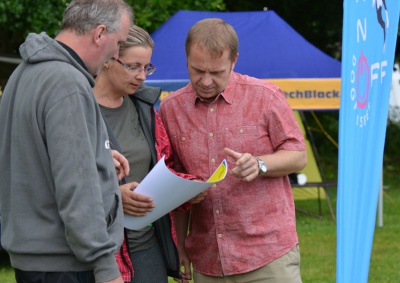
[[0, 0, 399, 59]]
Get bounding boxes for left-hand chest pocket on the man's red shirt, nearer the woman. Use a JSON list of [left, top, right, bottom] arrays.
[[173, 132, 208, 172]]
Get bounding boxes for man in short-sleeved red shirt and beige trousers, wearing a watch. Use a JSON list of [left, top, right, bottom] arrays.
[[160, 19, 307, 283]]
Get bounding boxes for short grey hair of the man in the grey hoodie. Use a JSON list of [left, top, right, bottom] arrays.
[[61, 0, 134, 35]]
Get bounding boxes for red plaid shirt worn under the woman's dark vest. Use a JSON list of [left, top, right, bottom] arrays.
[[115, 109, 195, 282]]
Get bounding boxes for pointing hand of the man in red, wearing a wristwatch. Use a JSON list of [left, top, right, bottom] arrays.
[[224, 148, 258, 182]]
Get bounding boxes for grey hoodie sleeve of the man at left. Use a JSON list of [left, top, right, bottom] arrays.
[[45, 90, 123, 282]]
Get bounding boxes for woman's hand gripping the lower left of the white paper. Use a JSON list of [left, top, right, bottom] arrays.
[[119, 182, 155, 216]]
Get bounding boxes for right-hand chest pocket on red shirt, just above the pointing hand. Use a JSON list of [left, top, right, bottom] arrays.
[[222, 125, 261, 164]]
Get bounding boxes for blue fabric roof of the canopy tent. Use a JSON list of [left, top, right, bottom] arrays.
[[148, 10, 341, 80]]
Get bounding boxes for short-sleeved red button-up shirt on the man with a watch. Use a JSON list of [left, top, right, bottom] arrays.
[[160, 72, 306, 276]]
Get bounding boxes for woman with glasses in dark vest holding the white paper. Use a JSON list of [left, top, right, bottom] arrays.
[[94, 26, 194, 283]]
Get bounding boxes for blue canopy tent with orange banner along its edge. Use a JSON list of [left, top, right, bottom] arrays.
[[146, 10, 341, 217]]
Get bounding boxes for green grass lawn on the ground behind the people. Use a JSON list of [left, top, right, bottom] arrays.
[[0, 168, 400, 283]]
